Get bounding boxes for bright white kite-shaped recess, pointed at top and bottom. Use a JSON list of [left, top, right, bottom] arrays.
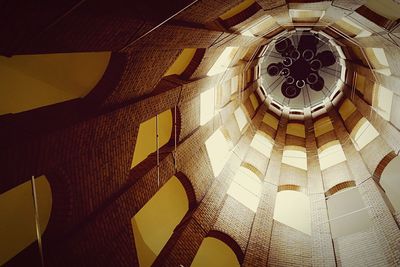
[[205, 129, 232, 177]]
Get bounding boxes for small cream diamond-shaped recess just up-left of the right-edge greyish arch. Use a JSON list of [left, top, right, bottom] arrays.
[[350, 118, 379, 151]]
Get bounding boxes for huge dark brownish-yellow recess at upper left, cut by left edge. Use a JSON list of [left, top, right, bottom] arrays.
[[0, 52, 111, 115]]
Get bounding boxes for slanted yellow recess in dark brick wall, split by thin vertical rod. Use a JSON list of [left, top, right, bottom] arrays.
[[131, 109, 173, 168]]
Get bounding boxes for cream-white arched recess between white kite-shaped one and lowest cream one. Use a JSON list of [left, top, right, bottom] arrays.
[[227, 167, 261, 212]]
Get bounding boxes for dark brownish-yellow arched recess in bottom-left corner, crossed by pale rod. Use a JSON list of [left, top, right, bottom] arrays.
[[0, 176, 52, 265]]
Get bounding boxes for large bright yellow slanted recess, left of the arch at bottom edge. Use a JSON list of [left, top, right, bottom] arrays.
[[131, 176, 189, 266]]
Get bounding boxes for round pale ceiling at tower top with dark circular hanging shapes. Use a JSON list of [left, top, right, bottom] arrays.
[[261, 29, 344, 109]]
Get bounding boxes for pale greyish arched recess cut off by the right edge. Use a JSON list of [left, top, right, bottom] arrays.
[[379, 156, 400, 213]]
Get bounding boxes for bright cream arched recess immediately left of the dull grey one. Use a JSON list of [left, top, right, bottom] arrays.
[[274, 190, 311, 235]]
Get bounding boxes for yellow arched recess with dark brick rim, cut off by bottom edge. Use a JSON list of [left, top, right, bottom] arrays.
[[191, 230, 244, 267]]
